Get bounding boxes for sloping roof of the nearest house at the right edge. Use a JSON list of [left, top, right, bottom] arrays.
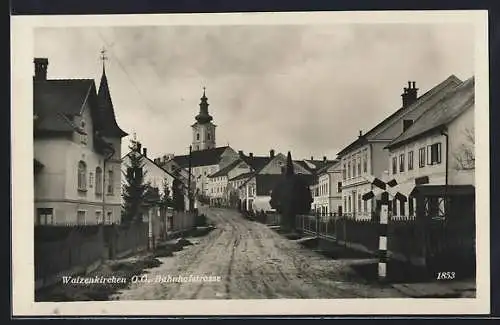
[[386, 77, 474, 149]]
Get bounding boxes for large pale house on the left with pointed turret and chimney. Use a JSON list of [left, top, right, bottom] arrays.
[[33, 58, 127, 226]]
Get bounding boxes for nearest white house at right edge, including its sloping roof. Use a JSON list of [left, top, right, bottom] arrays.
[[387, 78, 475, 216]]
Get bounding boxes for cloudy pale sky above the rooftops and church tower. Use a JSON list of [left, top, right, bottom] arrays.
[[34, 23, 474, 159]]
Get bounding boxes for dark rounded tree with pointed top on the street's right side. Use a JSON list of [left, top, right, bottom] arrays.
[[269, 151, 313, 231]]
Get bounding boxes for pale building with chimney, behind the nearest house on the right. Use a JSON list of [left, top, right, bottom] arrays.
[[338, 75, 461, 219]]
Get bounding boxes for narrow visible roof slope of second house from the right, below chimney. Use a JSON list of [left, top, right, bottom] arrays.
[[337, 75, 462, 156]]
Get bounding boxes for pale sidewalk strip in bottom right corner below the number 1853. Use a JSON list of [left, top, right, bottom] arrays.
[[390, 279, 476, 298]]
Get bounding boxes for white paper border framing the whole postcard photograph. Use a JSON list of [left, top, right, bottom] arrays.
[[11, 11, 490, 316]]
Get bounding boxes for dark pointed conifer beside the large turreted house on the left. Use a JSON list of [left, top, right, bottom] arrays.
[[122, 141, 149, 224]]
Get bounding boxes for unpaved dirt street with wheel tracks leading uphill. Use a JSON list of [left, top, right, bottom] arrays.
[[113, 208, 401, 300]]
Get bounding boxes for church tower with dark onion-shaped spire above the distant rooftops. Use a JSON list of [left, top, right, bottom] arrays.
[[191, 87, 216, 151]]
